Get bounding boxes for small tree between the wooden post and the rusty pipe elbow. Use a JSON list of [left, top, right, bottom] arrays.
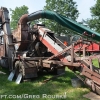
[[10, 5, 28, 30]]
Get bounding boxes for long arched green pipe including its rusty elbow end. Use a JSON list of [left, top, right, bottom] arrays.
[[19, 10, 100, 41]]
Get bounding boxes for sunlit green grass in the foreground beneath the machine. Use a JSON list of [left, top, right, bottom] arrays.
[[0, 66, 89, 100]]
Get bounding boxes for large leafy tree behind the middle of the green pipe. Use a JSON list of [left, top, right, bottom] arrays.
[[44, 0, 79, 34]]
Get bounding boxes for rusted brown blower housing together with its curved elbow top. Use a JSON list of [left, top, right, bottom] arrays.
[[12, 14, 31, 50]]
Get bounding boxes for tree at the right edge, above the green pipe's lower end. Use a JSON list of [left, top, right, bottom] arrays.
[[86, 0, 100, 33]]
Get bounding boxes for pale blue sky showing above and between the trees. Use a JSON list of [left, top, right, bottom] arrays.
[[0, 0, 96, 21]]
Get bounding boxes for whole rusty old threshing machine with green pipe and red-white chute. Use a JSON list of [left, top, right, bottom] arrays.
[[0, 7, 100, 95]]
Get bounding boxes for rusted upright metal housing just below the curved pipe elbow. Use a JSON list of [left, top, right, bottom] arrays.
[[13, 25, 31, 50]]
